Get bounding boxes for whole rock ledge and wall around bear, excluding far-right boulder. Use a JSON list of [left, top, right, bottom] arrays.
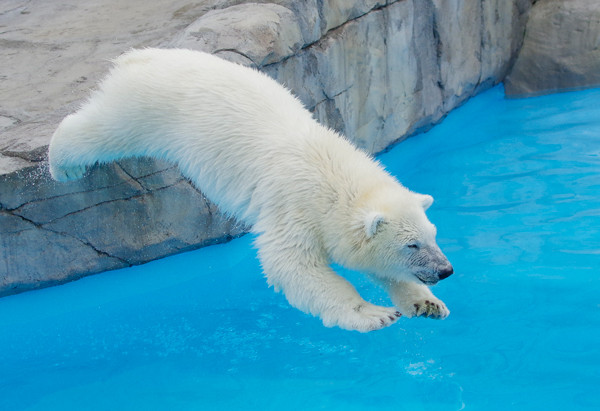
[[0, 0, 530, 295]]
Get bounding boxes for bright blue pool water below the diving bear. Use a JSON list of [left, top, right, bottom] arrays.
[[0, 88, 600, 411]]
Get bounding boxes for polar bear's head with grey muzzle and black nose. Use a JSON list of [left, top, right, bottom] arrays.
[[340, 190, 453, 285]]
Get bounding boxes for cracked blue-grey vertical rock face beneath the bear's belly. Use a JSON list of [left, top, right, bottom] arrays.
[[0, 160, 247, 296]]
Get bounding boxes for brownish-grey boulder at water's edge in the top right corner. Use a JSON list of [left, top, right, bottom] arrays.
[[506, 0, 600, 96]]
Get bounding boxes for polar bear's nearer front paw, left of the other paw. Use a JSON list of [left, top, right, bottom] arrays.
[[323, 301, 402, 333]]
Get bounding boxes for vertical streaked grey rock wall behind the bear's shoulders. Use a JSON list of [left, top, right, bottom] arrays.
[[262, 0, 529, 153]]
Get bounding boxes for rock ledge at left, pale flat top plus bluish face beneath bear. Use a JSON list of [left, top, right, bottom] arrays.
[[0, 0, 244, 295]]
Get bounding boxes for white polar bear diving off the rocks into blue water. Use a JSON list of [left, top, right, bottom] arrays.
[[49, 49, 452, 332]]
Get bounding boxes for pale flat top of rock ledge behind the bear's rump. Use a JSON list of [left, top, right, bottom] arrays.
[[0, 0, 230, 173]]
